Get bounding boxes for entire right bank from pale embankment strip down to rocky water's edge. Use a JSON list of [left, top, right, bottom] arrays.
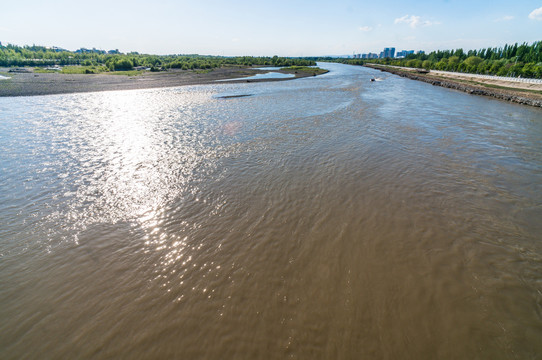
[[365, 64, 542, 107]]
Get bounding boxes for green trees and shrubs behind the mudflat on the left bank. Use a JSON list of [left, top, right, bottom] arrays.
[[0, 44, 316, 74]]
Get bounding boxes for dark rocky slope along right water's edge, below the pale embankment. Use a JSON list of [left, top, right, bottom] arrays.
[[364, 64, 542, 107]]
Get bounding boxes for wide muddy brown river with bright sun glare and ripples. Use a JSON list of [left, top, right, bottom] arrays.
[[0, 64, 542, 359]]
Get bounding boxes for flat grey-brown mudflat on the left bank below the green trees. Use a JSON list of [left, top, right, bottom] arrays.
[[0, 66, 325, 97]]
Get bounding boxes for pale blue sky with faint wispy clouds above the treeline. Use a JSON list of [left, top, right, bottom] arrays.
[[0, 0, 542, 56]]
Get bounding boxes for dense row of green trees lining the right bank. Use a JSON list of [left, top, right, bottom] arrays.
[[326, 41, 542, 79]]
